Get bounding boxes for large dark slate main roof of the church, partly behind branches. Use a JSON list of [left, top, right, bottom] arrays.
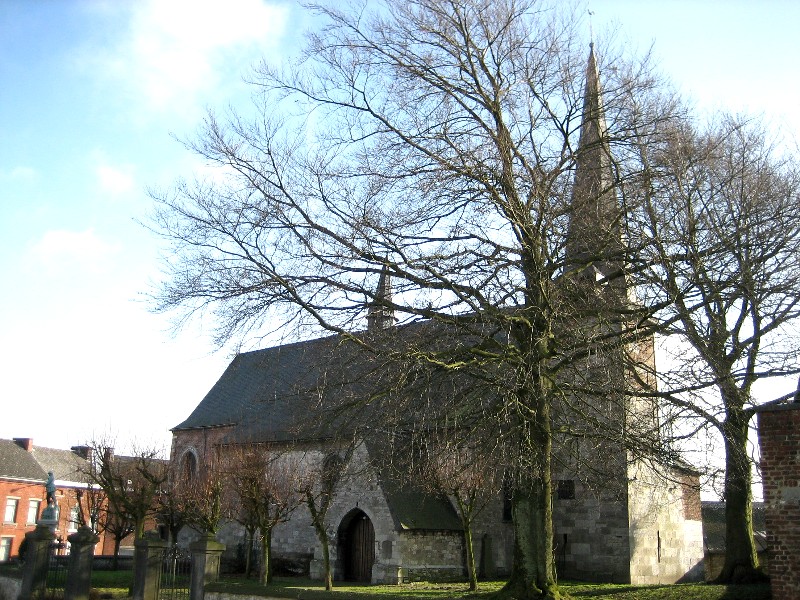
[[172, 322, 476, 443]]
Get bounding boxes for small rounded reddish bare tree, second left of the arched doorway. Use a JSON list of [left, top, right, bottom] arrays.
[[222, 444, 303, 585]]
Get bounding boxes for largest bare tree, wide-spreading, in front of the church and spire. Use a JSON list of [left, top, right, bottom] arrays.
[[154, 0, 674, 598]]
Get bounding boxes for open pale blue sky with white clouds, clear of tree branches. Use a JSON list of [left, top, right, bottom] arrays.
[[0, 0, 800, 458]]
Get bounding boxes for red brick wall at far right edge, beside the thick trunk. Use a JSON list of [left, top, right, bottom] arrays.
[[758, 404, 800, 600]]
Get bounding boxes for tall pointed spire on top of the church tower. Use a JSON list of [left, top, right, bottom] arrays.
[[566, 43, 622, 277]]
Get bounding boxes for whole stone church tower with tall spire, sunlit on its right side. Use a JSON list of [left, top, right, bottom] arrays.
[[553, 45, 703, 584]]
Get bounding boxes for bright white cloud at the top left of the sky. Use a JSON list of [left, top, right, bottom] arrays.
[[106, 0, 288, 114]]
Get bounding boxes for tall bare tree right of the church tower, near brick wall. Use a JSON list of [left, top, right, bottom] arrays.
[[632, 117, 800, 582]]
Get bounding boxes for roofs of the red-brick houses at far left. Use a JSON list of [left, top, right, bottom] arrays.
[[0, 440, 86, 482]]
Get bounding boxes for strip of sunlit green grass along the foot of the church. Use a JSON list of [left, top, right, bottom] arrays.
[[205, 578, 771, 600]]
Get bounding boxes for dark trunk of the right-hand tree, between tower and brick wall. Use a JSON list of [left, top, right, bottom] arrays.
[[716, 408, 763, 583]]
